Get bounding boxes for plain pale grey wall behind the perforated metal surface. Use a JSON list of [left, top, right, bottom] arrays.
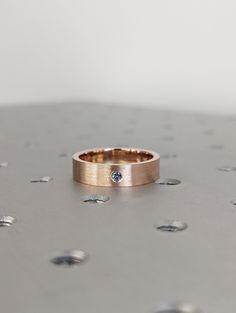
[[0, 0, 236, 113]]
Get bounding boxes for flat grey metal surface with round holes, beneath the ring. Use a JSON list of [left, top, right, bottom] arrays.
[[0, 104, 236, 313]]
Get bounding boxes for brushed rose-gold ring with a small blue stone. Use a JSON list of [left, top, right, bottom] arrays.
[[73, 148, 160, 187]]
